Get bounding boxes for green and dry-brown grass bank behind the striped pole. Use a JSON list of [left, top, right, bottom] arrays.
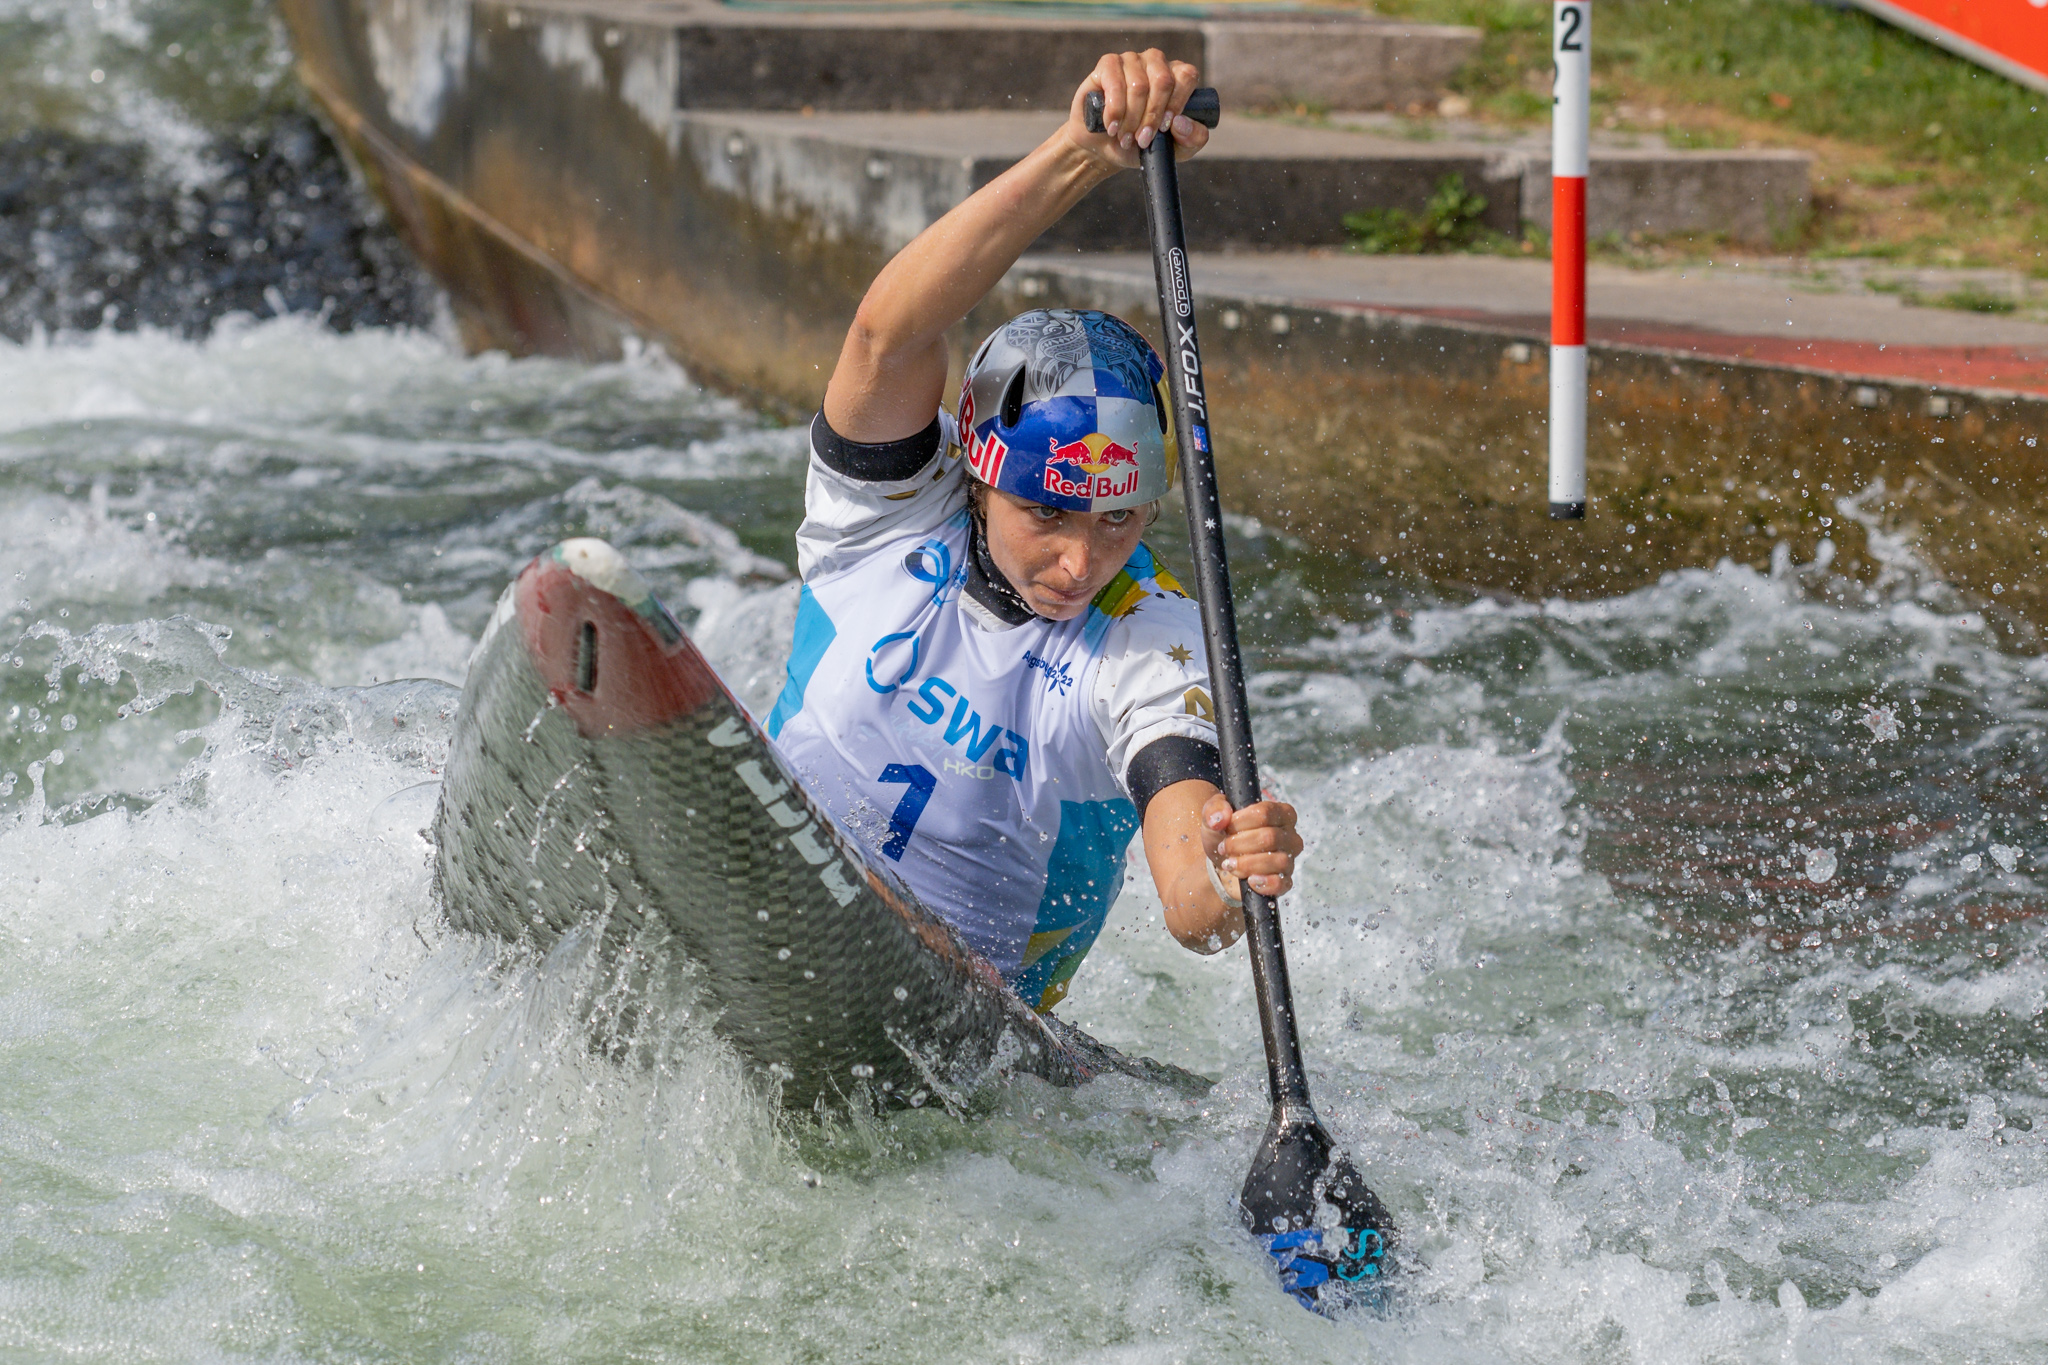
[[1372, 0, 2048, 274]]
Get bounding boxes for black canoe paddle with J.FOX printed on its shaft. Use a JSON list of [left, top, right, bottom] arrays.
[[1083, 90, 1395, 1308]]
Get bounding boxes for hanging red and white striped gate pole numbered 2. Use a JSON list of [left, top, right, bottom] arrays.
[[1550, 0, 1593, 522]]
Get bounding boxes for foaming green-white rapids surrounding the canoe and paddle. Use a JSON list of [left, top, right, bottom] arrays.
[[0, 319, 2048, 1361]]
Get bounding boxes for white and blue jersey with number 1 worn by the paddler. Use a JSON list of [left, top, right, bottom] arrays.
[[768, 413, 1217, 1009]]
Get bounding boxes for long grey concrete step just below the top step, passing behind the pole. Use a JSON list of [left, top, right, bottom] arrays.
[[680, 111, 1808, 252]]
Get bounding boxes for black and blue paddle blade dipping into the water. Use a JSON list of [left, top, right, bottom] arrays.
[[1241, 1115, 1395, 1312]]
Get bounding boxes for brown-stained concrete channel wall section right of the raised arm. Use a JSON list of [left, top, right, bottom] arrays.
[[967, 258, 2048, 647]]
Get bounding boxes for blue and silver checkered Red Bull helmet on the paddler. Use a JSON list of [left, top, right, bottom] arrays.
[[958, 309, 1174, 512]]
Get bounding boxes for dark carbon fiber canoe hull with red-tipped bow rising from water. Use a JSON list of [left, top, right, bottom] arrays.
[[434, 540, 1105, 1109]]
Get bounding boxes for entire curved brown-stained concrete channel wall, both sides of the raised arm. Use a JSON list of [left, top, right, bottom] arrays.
[[283, 0, 2048, 641]]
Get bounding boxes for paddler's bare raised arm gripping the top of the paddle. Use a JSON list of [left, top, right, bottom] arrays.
[[825, 47, 1208, 444]]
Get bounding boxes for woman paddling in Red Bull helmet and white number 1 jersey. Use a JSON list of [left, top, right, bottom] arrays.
[[768, 49, 1303, 1011]]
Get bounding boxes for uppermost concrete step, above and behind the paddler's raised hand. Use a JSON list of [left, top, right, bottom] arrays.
[[630, 0, 1481, 113]]
